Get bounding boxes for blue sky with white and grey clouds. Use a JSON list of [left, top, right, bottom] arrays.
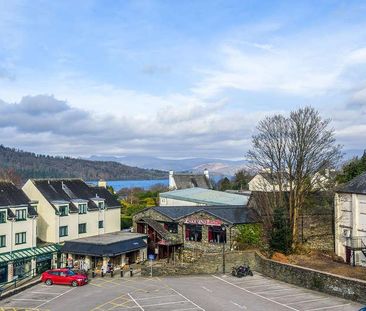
[[0, 0, 366, 159]]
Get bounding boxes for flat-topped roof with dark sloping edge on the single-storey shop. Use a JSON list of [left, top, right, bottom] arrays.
[[61, 231, 147, 257]]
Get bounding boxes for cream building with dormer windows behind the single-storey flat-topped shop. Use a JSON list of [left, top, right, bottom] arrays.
[[23, 179, 121, 243]]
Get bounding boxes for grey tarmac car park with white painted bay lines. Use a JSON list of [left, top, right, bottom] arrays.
[[0, 273, 362, 311]]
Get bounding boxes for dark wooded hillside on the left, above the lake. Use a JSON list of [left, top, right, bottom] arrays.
[[0, 145, 168, 181]]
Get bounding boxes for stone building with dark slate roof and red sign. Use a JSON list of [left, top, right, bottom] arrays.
[[133, 205, 260, 258]]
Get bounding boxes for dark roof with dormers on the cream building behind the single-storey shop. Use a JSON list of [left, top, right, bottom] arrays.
[[32, 179, 120, 211]]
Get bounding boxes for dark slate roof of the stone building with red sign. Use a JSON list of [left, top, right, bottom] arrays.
[[137, 205, 260, 224]]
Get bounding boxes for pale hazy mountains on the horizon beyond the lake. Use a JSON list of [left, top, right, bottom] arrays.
[[89, 156, 247, 176]]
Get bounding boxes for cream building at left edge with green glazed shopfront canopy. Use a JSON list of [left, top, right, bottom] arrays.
[[0, 181, 57, 283]]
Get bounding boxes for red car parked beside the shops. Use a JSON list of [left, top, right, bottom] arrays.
[[41, 269, 88, 287]]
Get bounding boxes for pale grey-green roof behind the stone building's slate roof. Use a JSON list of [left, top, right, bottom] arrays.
[[160, 188, 248, 206]]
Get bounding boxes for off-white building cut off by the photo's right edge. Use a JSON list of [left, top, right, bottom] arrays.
[[334, 172, 366, 266]]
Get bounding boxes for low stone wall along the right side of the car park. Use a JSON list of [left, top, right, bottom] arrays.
[[255, 253, 366, 303]]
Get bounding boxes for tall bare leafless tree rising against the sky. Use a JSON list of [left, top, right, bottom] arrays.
[[248, 107, 341, 246]]
